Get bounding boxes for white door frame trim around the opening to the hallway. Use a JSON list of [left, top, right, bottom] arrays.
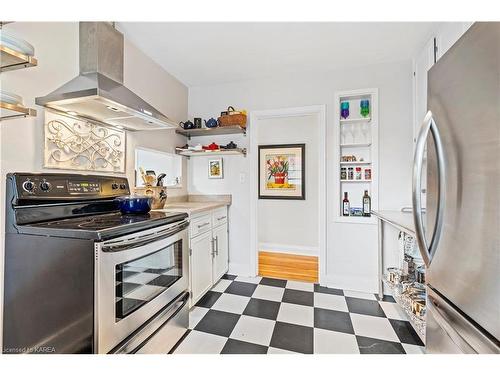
[[248, 104, 327, 282]]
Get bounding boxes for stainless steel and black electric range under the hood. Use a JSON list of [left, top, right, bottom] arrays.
[[3, 173, 189, 353]]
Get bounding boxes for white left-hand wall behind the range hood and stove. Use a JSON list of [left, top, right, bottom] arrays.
[[0, 22, 188, 341]]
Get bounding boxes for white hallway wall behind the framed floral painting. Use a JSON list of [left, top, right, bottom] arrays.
[[254, 115, 319, 255]]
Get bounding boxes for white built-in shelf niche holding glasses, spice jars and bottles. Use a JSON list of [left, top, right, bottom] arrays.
[[334, 89, 378, 224]]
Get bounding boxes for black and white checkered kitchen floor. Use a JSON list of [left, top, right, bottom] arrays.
[[174, 275, 424, 354]]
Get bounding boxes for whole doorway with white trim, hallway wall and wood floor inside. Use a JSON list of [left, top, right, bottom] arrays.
[[249, 105, 326, 282]]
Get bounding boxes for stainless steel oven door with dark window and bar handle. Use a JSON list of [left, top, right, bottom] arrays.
[[94, 220, 189, 353]]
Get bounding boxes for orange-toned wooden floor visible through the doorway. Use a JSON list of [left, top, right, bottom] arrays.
[[259, 251, 318, 282]]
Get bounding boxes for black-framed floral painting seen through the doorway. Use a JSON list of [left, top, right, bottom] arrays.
[[259, 143, 306, 200]]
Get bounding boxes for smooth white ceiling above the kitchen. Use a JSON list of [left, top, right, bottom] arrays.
[[117, 22, 438, 87]]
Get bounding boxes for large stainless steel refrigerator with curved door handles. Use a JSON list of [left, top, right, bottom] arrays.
[[413, 23, 500, 353]]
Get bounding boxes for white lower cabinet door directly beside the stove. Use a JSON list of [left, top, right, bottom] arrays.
[[190, 231, 213, 301]]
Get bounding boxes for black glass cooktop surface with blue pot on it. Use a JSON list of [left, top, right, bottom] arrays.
[[23, 211, 187, 239]]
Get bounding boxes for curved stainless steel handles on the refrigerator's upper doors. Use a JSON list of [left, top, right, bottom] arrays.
[[412, 111, 446, 267]]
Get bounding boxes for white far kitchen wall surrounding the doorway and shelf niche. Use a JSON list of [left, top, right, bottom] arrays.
[[188, 61, 413, 291]]
